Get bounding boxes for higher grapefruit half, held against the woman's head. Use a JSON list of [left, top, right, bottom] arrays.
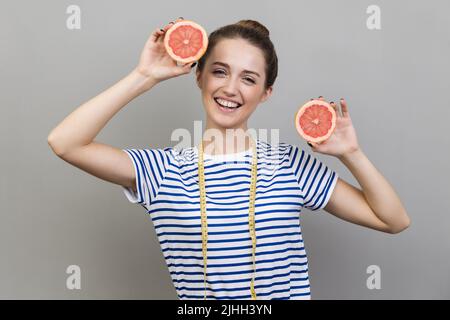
[[164, 20, 208, 64]]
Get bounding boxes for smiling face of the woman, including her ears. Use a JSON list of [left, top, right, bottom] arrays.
[[197, 39, 272, 129]]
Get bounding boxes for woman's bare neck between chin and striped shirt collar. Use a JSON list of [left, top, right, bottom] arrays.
[[202, 122, 252, 155]]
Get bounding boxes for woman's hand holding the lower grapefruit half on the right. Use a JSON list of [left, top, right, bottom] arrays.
[[308, 96, 359, 158]]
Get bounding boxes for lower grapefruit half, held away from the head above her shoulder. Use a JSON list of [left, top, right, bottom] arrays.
[[295, 99, 336, 143]]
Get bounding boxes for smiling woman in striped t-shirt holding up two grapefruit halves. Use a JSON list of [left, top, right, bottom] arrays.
[[48, 18, 409, 299]]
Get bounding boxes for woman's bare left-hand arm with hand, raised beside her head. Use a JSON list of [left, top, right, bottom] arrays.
[[47, 17, 191, 188]]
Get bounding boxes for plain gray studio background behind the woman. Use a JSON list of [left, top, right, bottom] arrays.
[[0, 0, 450, 299]]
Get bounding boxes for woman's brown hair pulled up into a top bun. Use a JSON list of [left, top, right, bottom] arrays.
[[198, 20, 278, 89]]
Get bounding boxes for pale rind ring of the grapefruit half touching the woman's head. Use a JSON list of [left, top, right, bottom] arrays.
[[164, 20, 208, 64]]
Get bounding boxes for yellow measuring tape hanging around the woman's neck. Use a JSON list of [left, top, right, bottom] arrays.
[[198, 137, 257, 300]]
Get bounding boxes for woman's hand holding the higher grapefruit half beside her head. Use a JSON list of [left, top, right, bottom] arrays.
[[136, 17, 196, 83]]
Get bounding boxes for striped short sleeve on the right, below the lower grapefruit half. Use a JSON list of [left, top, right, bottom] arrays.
[[289, 146, 339, 211]]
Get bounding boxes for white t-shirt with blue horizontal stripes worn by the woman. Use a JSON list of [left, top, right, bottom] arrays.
[[122, 140, 338, 300]]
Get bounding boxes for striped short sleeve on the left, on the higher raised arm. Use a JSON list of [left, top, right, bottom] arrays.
[[122, 148, 170, 209]]
